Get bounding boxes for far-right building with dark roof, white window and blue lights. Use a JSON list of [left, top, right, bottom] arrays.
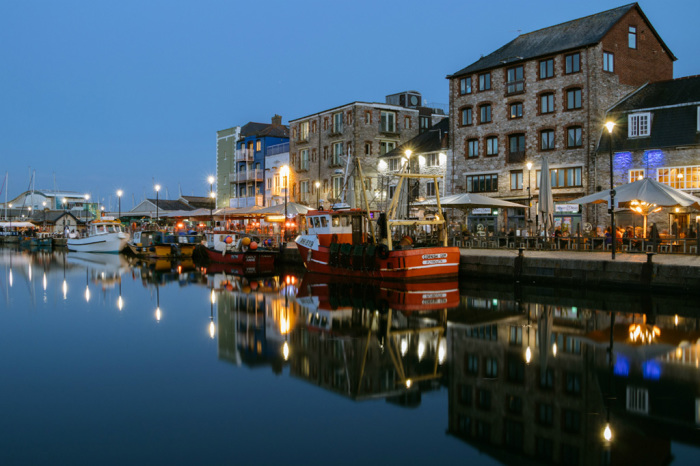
[[594, 76, 700, 237]]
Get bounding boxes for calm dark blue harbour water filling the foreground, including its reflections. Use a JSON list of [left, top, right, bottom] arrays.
[[0, 248, 700, 465]]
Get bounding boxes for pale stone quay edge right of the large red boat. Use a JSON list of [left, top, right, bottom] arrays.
[[460, 248, 700, 268]]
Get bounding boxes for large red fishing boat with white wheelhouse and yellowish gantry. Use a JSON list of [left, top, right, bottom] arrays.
[[296, 173, 460, 280]]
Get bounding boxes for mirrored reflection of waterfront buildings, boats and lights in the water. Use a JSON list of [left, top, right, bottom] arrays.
[[0, 249, 700, 465]]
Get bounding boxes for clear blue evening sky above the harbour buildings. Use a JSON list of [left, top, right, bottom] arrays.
[[0, 0, 700, 210]]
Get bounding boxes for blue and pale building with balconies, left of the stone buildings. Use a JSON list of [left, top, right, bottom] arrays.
[[216, 115, 289, 207]]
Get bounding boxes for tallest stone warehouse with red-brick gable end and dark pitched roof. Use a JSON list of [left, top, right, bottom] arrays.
[[447, 3, 676, 235]]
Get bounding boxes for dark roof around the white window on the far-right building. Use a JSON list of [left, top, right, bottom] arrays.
[[598, 76, 700, 153]]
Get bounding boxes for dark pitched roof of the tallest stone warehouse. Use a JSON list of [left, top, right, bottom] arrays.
[[448, 3, 675, 78]]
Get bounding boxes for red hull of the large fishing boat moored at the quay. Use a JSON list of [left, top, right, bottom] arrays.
[[297, 242, 460, 281]]
